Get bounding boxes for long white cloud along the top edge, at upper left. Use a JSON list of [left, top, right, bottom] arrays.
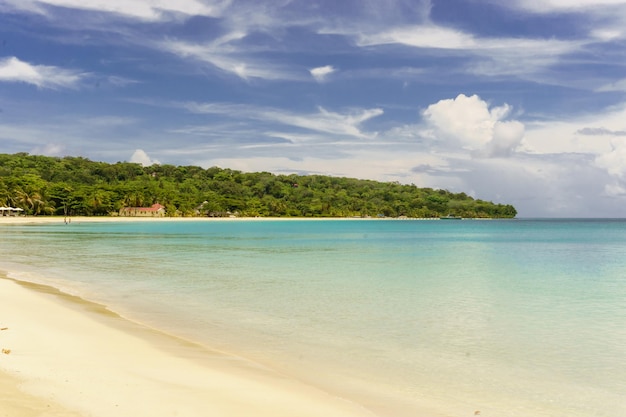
[[4, 0, 231, 21]]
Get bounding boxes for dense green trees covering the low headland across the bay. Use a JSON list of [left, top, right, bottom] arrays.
[[0, 153, 516, 217]]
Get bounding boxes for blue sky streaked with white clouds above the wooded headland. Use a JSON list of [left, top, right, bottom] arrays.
[[0, 0, 626, 217]]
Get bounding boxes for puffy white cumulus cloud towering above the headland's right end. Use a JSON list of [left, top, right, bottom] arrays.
[[422, 94, 524, 156]]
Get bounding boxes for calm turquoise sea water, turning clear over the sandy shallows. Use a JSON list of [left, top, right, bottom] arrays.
[[0, 220, 626, 417]]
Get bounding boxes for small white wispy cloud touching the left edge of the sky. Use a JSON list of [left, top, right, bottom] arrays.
[[0, 57, 87, 89]]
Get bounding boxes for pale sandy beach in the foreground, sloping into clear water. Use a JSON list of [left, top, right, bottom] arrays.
[[0, 276, 374, 417]]
